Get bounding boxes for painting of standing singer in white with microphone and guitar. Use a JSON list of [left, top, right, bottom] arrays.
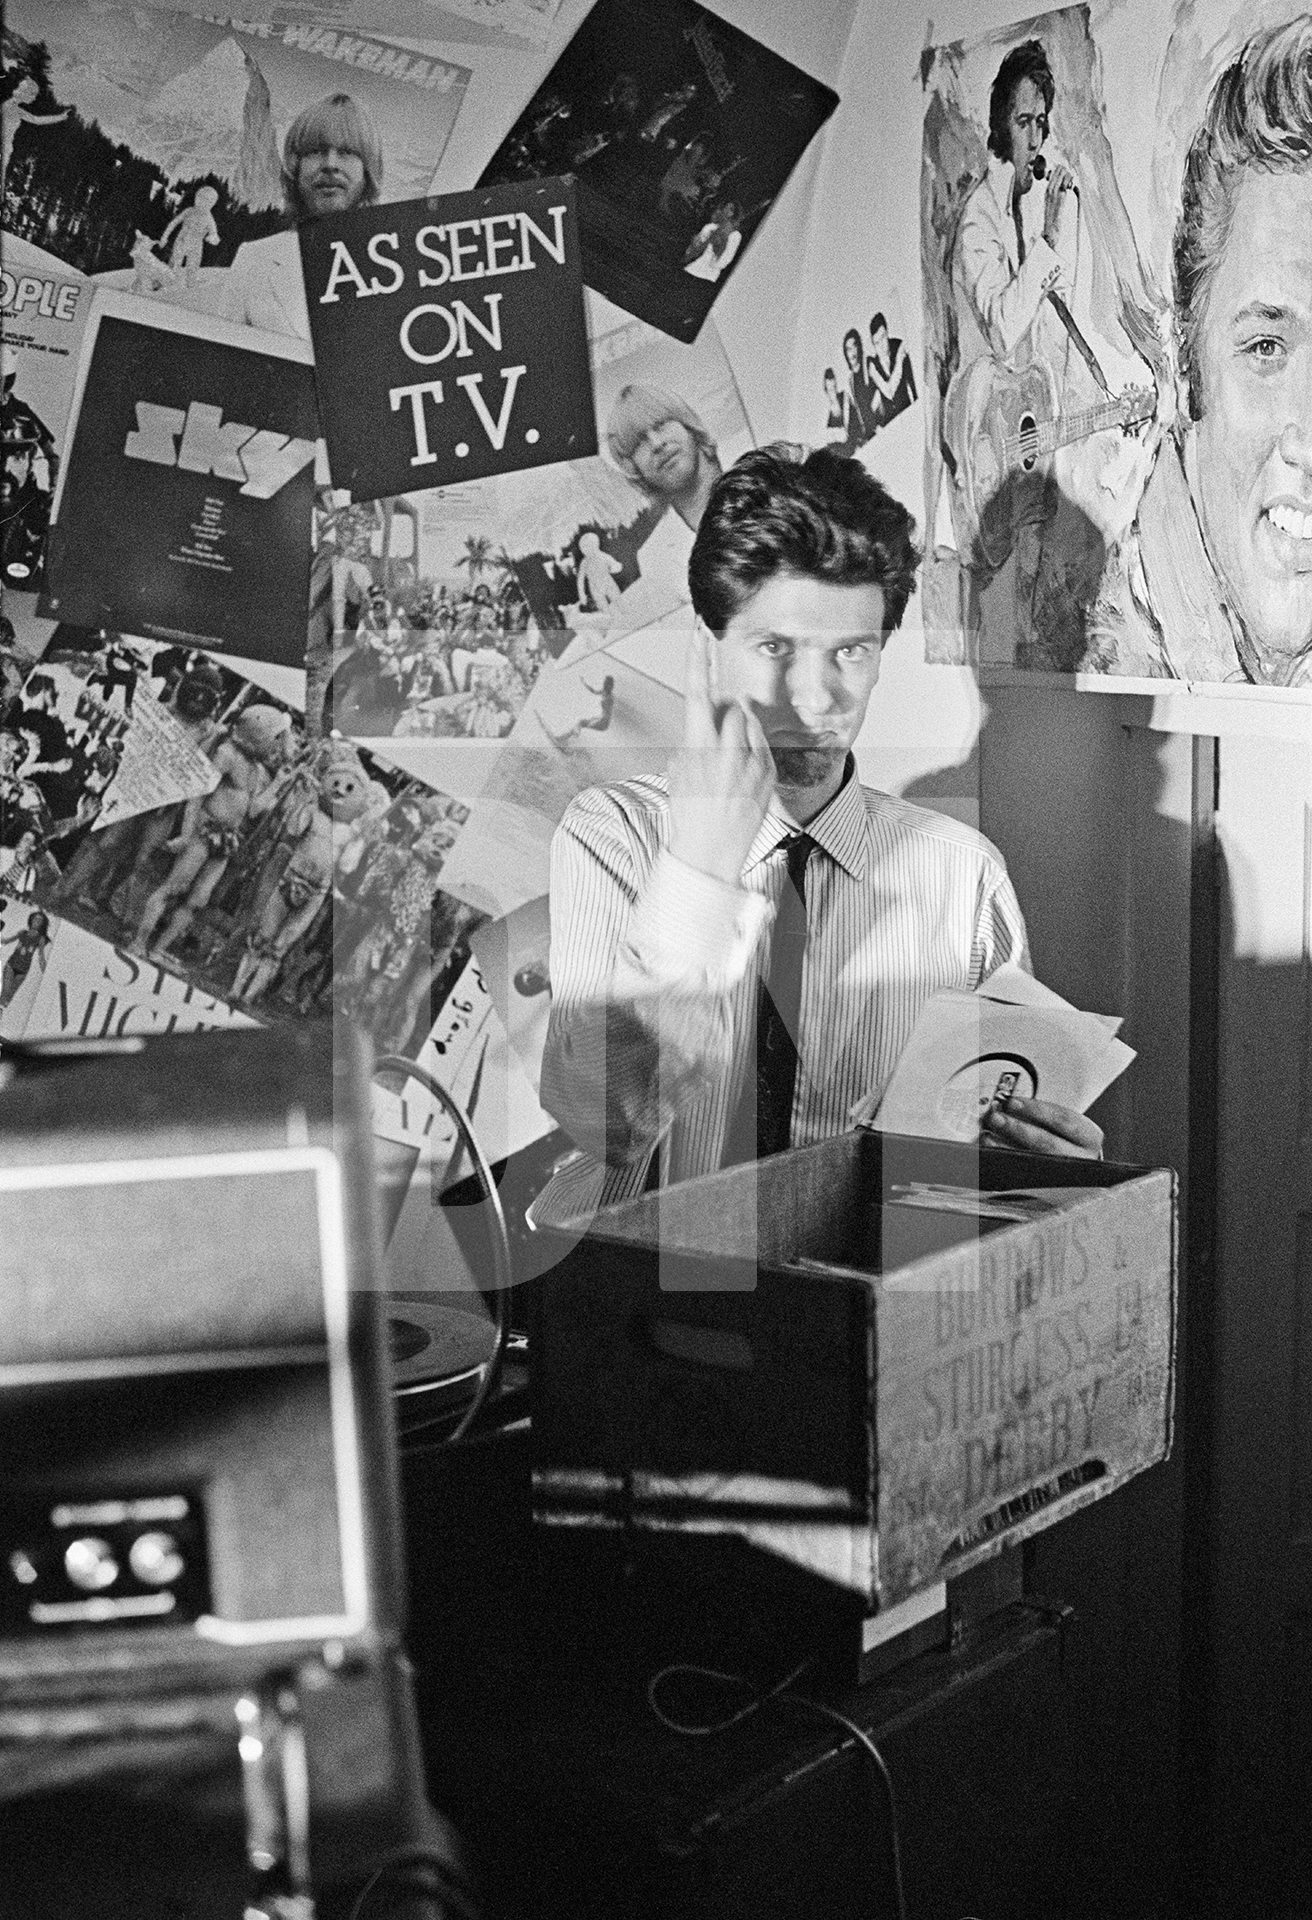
[[920, 8, 1168, 672]]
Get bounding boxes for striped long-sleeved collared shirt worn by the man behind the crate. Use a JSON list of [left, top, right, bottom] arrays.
[[534, 760, 1030, 1219]]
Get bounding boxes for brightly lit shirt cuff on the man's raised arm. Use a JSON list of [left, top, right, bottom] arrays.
[[624, 851, 772, 991]]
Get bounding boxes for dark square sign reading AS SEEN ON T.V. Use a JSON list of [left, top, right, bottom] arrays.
[[300, 180, 597, 499]]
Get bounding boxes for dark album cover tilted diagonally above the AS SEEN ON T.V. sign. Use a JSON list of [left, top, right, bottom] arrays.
[[478, 0, 838, 340]]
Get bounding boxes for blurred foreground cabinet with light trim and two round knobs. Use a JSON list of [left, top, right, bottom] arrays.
[[0, 1029, 400, 1692]]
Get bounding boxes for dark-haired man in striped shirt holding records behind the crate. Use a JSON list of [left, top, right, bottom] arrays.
[[534, 447, 1103, 1219]]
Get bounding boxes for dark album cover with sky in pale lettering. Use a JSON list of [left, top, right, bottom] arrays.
[[46, 290, 319, 666]]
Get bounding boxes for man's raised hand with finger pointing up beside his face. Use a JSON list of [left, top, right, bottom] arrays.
[[668, 620, 774, 885]]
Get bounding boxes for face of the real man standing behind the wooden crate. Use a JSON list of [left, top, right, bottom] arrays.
[[711, 574, 884, 787]]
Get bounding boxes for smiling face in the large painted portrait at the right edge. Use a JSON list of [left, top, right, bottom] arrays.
[[1197, 169, 1312, 680]]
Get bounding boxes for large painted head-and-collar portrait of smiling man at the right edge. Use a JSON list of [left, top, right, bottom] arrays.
[[1083, 13, 1312, 687]]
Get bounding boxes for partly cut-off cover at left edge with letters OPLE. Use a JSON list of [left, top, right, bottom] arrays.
[[0, 236, 90, 593]]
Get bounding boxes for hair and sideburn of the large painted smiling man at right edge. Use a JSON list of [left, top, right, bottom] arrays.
[[1174, 13, 1312, 420]]
